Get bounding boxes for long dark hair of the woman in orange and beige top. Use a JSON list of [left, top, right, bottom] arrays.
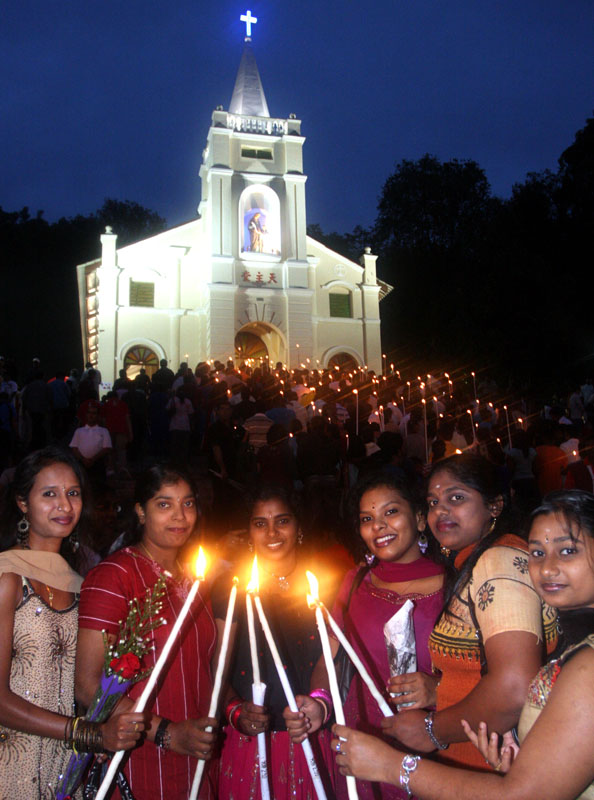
[[427, 453, 511, 614]]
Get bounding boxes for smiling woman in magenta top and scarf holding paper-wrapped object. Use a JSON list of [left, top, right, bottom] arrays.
[[287, 472, 444, 800]]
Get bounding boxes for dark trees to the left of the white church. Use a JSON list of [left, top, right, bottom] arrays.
[[0, 198, 165, 377]]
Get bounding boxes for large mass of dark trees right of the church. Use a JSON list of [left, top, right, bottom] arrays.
[[311, 119, 594, 386]]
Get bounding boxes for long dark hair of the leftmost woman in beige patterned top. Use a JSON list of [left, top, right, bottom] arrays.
[[0, 445, 89, 569]]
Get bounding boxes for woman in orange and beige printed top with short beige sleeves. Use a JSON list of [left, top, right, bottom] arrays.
[[382, 454, 556, 769]]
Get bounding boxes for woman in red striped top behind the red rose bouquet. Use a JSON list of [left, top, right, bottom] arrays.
[[76, 466, 217, 800]]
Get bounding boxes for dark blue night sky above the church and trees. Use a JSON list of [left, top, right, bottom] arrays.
[[0, 0, 594, 232]]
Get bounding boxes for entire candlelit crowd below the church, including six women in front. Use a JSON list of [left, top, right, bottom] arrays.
[[0, 360, 594, 800]]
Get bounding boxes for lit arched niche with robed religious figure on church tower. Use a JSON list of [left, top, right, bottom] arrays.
[[239, 185, 280, 256]]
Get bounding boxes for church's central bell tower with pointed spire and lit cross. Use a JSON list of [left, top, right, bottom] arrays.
[[198, 11, 312, 362]]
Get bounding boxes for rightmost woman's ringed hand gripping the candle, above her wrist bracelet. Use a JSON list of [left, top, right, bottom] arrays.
[[330, 725, 404, 785]]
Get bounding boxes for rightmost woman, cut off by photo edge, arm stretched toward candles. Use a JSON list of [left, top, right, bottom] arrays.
[[333, 490, 594, 800]]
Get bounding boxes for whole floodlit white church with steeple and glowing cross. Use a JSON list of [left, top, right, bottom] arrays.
[[77, 11, 391, 382]]
